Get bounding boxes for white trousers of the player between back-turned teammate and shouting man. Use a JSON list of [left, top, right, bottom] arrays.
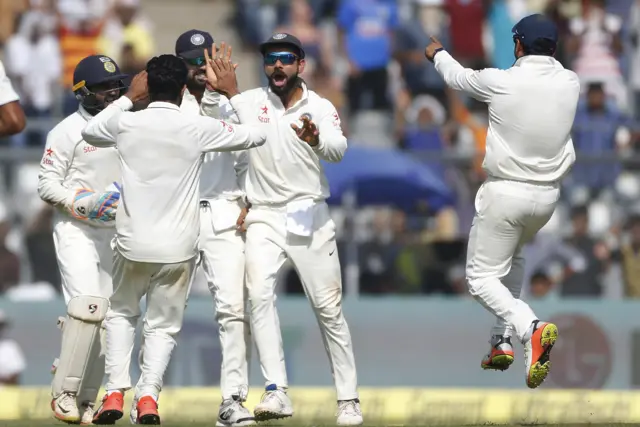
[[199, 200, 252, 399]]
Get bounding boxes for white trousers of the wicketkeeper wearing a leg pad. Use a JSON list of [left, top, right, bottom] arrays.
[[53, 218, 115, 403]]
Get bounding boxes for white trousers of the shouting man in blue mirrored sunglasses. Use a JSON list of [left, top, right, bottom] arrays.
[[245, 202, 358, 400]]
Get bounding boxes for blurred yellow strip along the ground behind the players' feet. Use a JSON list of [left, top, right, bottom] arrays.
[[0, 387, 640, 427]]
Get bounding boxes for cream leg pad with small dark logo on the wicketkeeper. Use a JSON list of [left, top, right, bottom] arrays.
[[51, 295, 109, 403]]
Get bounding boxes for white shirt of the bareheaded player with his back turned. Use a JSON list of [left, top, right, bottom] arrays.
[[82, 97, 266, 263]]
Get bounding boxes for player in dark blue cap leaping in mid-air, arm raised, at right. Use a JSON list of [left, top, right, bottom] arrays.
[[425, 14, 580, 388]]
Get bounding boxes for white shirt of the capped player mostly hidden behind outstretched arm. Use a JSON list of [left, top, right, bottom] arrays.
[[180, 90, 248, 200]]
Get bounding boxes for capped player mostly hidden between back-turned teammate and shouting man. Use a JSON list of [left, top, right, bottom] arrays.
[[175, 30, 255, 426]]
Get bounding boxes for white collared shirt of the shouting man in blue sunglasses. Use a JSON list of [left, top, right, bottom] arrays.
[[230, 84, 347, 205]]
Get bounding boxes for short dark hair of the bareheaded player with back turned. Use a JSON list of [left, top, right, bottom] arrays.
[[147, 55, 189, 102]]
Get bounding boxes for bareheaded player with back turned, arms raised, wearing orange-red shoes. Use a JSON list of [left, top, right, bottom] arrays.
[[83, 55, 266, 424]]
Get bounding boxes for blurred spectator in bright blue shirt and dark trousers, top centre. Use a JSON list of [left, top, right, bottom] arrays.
[[338, 0, 398, 113]]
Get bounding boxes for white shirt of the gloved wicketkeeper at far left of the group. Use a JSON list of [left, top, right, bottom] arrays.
[[38, 107, 120, 227]]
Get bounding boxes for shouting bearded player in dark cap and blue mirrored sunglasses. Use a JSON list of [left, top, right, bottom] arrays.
[[208, 34, 362, 425]]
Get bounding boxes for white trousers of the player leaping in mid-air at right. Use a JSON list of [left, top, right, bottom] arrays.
[[466, 179, 560, 341]]
